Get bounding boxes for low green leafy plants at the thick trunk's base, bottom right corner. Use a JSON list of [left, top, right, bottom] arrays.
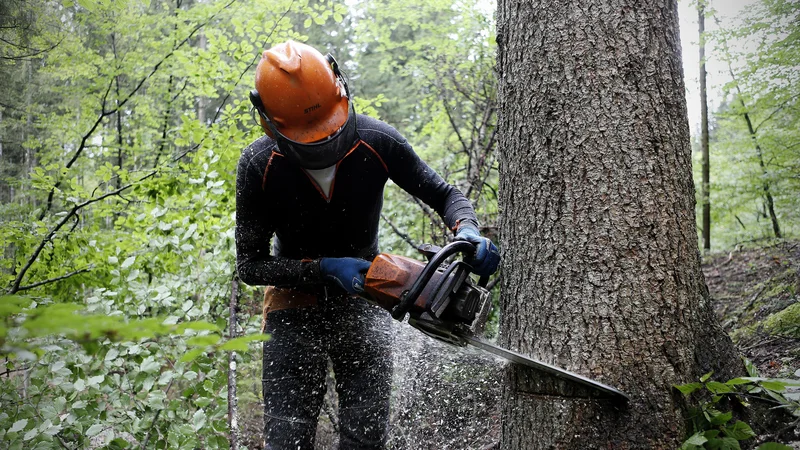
[[675, 360, 800, 450]]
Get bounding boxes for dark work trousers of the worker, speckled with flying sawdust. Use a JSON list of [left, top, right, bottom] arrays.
[[262, 297, 392, 450]]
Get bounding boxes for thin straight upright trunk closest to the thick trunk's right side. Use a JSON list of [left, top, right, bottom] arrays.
[[697, 0, 711, 251]]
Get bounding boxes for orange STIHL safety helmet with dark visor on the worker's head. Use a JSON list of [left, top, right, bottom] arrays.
[[250, 41, 357, 169]]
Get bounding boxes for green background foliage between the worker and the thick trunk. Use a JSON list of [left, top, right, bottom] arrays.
[[350, 0, 498, 251]]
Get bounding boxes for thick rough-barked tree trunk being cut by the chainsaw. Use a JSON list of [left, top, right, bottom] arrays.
[[497, 0, 742, 449]]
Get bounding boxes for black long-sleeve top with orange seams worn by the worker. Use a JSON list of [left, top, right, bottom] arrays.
[[236, 115, 478, 287]]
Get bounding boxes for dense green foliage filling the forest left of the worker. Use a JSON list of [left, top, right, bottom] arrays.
[[0, 0, 334, 449]]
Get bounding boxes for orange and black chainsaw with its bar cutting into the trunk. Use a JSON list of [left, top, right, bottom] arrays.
[[362, 241, 629, 401]]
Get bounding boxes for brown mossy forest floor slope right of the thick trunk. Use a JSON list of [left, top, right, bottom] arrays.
[[703, 242, 800, 449]]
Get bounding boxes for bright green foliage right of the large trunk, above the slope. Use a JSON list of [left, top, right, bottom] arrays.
[[695, 0, 800, 248]]
